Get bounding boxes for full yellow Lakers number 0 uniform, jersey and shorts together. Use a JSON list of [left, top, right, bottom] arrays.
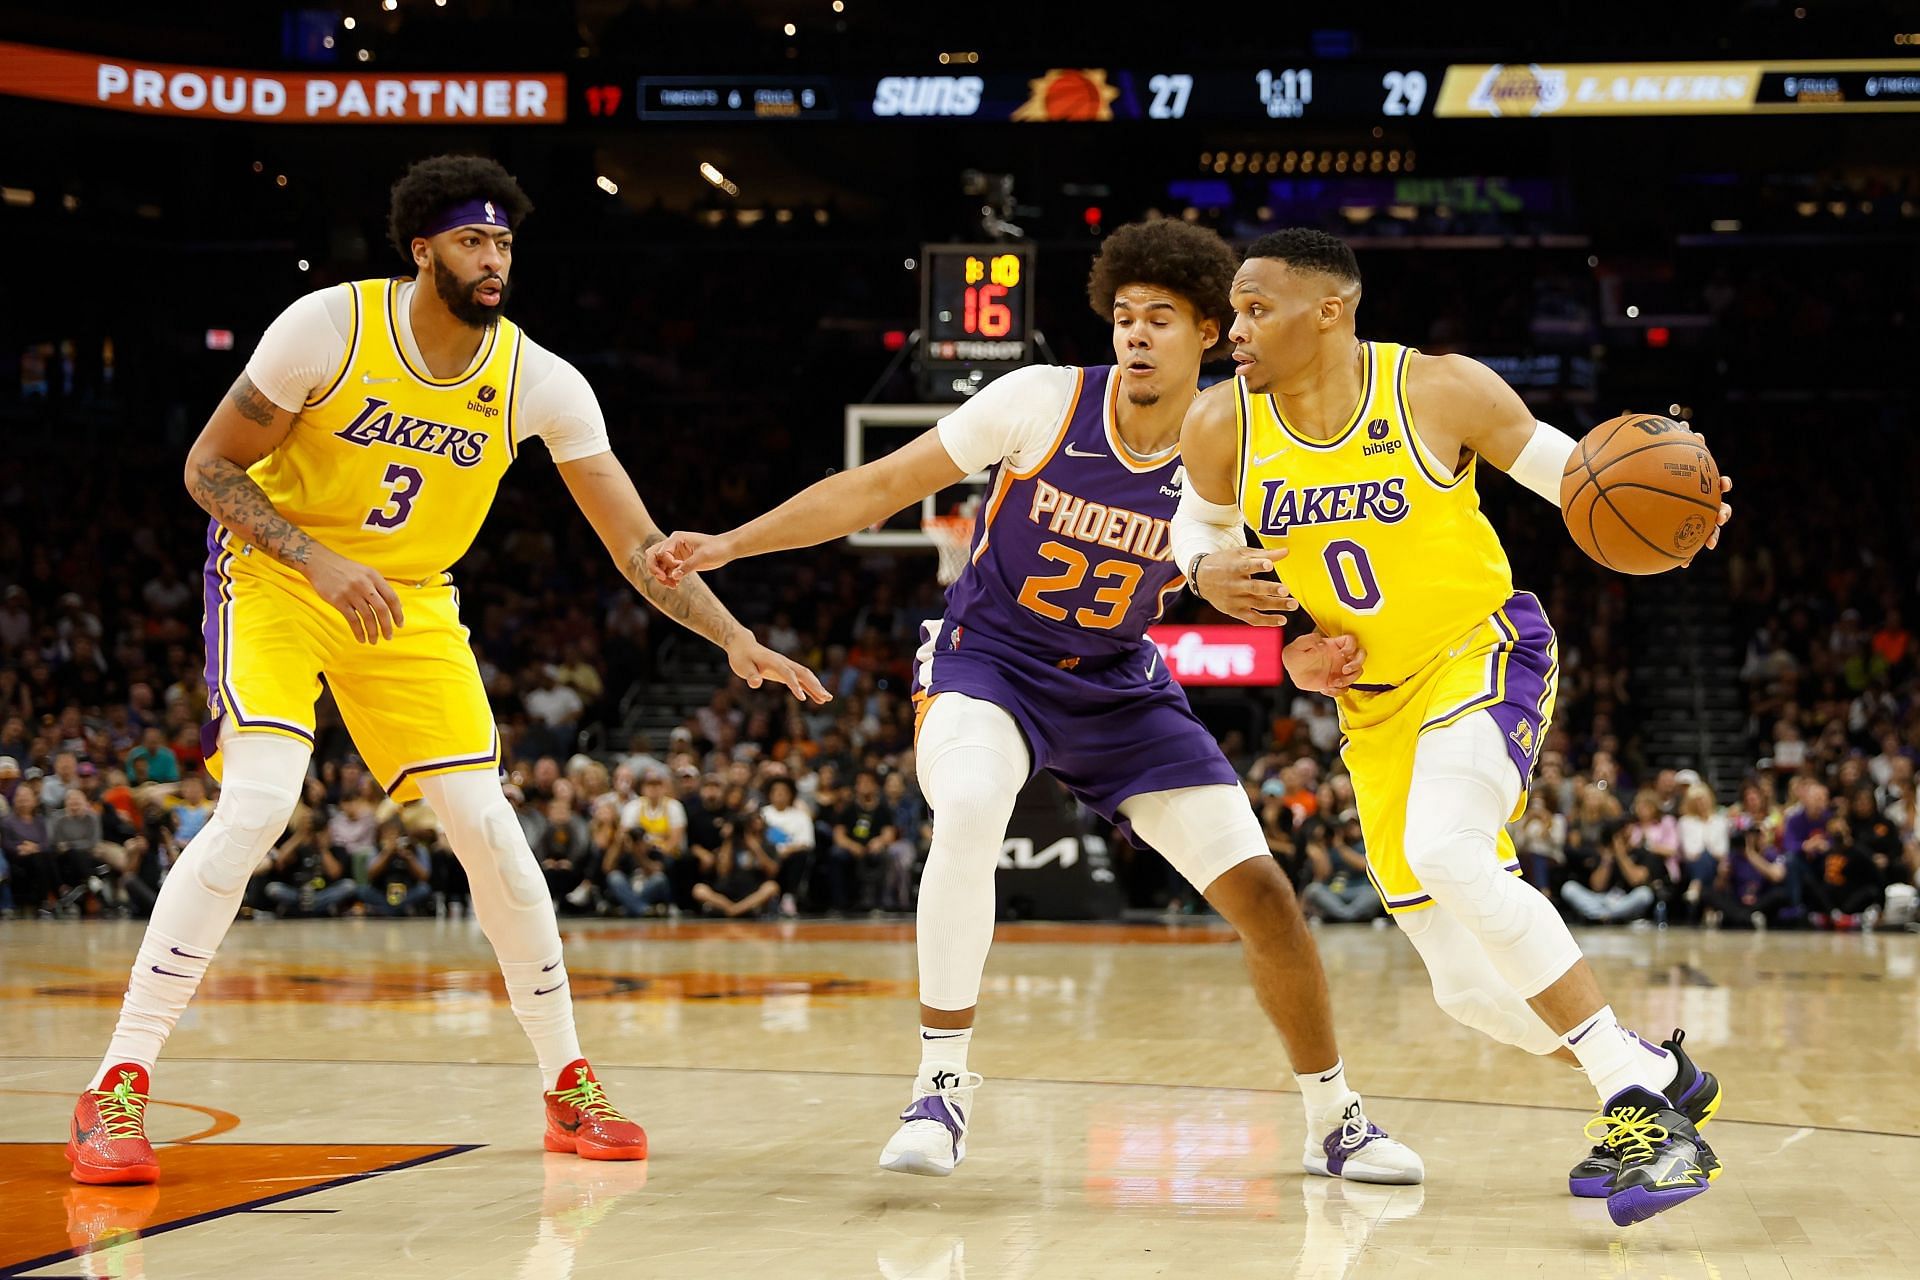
[[1238, 342, 1559, 912]]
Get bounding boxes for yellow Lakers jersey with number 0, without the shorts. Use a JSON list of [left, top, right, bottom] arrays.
[[1238, 342, 1513, 685]]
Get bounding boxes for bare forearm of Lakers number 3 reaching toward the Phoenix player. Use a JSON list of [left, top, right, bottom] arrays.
[[557, 453, 831, 702]]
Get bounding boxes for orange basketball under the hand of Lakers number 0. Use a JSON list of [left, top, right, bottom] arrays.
[[1561, 413, 1720, 574]]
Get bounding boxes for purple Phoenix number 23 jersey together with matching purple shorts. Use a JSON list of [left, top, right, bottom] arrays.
[[914, 367, 1238, 821]]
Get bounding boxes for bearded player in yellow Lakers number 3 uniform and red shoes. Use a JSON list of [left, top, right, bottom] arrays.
[[67, 155, 826, 1182]]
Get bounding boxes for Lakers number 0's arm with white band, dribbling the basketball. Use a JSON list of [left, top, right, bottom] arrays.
[[1407, 355, 1734, 564]]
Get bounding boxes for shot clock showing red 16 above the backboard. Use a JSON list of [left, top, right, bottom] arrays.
[[920, 244, 1033, 365]]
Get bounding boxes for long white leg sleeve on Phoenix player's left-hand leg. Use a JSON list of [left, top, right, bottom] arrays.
[[914, 693, 1031, 1009]]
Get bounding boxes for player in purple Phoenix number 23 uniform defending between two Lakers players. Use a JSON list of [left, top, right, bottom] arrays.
[[649, 221, 1425, 1182]]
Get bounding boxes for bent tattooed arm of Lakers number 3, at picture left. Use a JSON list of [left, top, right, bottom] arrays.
[[186, 372, 405, 645]]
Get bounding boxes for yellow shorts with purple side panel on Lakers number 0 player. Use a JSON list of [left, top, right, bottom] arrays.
[[1340, 591, 1559, 913]]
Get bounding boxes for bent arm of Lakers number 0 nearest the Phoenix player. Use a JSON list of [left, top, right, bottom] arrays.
[[1173, 382, 1298, 628]]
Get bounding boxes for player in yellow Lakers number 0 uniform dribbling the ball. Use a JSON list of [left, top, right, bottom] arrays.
[[1173, 230, 1732, 1226]]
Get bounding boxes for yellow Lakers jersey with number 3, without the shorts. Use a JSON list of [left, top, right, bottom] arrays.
[[248, 280, 520, 581]]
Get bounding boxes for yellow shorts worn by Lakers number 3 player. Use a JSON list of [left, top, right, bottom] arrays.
[[202, 526, 499, 804]]
